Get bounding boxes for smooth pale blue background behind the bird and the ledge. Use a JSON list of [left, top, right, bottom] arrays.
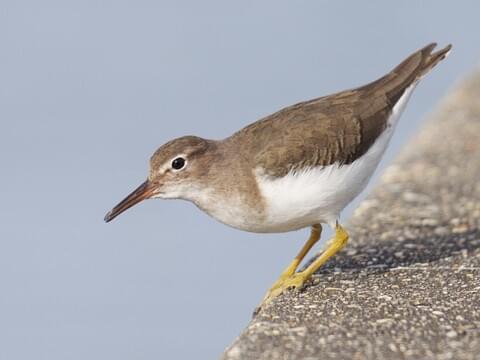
[[0, 0, 480, 360]]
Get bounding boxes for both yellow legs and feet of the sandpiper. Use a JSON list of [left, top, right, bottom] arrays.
[[261, 223, 348, 306]]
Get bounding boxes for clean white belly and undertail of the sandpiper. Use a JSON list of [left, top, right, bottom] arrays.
[[256, 83, 416, 232]]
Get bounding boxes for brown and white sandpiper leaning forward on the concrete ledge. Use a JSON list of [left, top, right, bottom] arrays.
[[105, 44, 451, 310]]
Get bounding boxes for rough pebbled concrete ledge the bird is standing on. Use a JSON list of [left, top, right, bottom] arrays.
[[222, 72, 480, 360]]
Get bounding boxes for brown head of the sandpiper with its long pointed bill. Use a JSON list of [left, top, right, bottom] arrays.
[[105, 136, 216, 222]]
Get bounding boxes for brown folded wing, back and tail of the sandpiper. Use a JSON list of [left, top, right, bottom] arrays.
[[233, 44, 451, 177]]
